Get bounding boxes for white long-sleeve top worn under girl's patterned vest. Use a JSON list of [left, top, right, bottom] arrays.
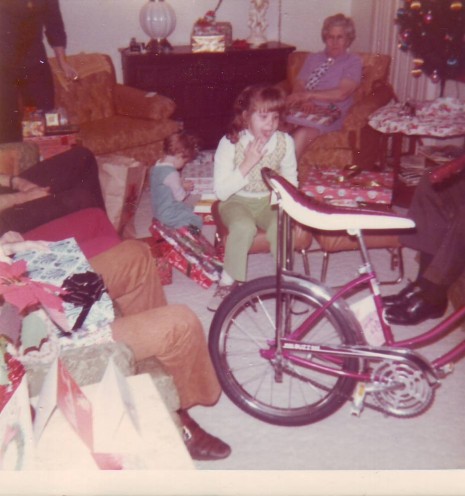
[[213, 130, 297, 201]]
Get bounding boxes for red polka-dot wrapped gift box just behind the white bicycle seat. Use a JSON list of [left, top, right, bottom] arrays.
[[300, 168, 394, 204]]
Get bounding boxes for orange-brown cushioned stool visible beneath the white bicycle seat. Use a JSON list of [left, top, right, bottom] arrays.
[[312, 231, 404, 284]]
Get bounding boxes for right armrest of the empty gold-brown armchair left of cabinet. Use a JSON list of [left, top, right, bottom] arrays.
[[114, 84, 176, 121]]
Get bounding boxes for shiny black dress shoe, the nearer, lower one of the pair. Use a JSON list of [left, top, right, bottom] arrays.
[[385, 291, 447, 325]]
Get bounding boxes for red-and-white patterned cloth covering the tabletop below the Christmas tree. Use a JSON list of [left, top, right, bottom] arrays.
[[369, 97, 465, 138]]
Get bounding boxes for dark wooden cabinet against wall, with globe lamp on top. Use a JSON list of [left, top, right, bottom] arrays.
[[121, 42, 295, 148]]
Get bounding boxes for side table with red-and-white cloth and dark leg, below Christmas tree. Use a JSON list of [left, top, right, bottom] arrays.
[[369, 97, 465, 207]]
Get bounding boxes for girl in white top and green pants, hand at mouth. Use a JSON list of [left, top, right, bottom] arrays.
[[208, 85, 297, 311]]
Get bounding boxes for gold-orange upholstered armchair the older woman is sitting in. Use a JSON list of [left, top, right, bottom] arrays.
[[282, 51, 394, 179]]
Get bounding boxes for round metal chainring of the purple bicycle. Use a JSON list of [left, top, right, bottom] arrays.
[[372, 362, 434, 417]]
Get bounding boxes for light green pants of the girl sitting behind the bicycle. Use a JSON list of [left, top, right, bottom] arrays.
[[219, 195, 277, 282]]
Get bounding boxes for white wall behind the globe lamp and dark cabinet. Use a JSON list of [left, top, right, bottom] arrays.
[[49, 0, 356, 81]]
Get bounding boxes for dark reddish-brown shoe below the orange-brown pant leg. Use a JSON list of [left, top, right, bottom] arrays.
[[178, 411, 231, 460]]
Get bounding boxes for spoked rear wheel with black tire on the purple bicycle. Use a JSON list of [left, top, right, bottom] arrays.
[[208, 276, 361, 426]]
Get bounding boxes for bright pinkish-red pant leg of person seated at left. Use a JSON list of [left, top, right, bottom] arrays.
[[23, 208, 121, 258]]
